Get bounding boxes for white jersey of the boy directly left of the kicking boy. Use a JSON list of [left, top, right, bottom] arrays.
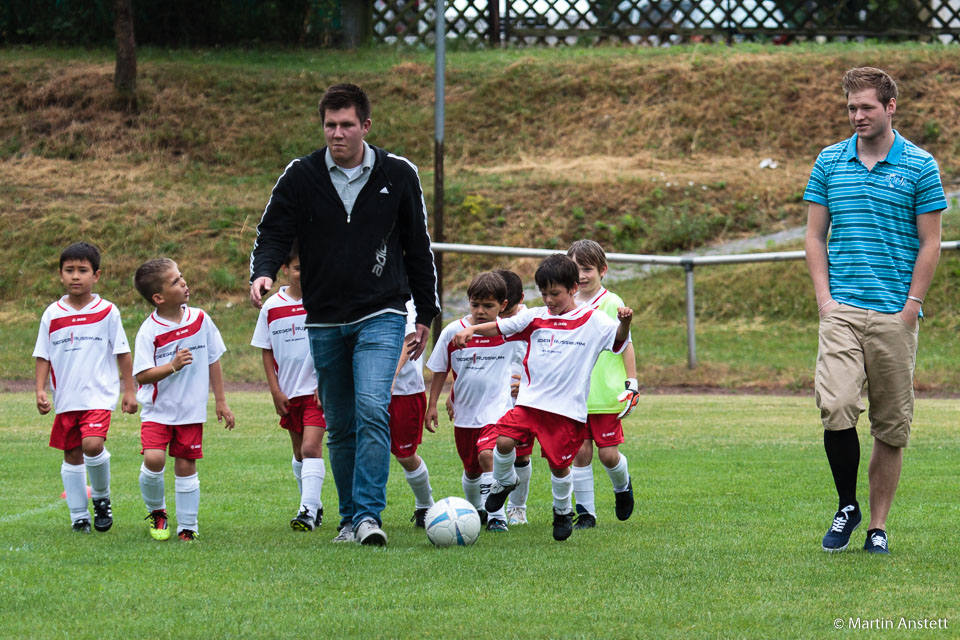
[[427, 316, 521, 429]]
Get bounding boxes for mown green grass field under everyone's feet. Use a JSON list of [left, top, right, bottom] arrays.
[[0, 393, 960, 639]]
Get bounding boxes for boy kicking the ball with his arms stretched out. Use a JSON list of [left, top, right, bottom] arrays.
[[452, 254, 633, 540]]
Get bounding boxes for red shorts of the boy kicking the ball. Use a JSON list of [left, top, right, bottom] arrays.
[[497, 406, 587, 469]]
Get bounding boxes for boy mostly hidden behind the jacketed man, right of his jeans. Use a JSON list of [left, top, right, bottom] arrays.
[[390, 299, 433, 529]]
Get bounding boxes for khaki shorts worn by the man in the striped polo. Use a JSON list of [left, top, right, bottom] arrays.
[[814, 304, 919, 447]]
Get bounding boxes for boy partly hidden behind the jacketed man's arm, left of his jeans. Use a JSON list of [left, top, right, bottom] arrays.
[[250, 242, 327, 531]]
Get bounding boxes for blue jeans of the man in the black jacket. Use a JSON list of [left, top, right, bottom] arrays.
[[307, 313, 406, 525]]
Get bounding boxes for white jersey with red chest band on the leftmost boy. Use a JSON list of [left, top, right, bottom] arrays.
[[33, 294, 130, 413]]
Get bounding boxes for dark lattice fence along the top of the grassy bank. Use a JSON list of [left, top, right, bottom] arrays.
[[373, 0, 960, 46]]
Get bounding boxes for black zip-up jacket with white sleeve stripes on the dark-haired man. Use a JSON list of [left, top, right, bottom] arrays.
[[250, 145, 440, 326]]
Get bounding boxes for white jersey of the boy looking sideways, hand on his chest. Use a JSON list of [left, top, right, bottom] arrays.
[[133, 305, 227, 425]]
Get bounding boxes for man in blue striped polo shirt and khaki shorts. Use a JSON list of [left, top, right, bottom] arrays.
[[803, 67, 947, 553]]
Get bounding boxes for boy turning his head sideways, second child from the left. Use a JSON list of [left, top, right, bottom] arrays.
[[133, 258, 234, 542]]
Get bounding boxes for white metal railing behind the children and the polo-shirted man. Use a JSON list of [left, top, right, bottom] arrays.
[[433, 240, 960, 369]]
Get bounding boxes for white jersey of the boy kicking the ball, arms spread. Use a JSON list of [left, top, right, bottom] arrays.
[[497, 306, 627, 422]]
